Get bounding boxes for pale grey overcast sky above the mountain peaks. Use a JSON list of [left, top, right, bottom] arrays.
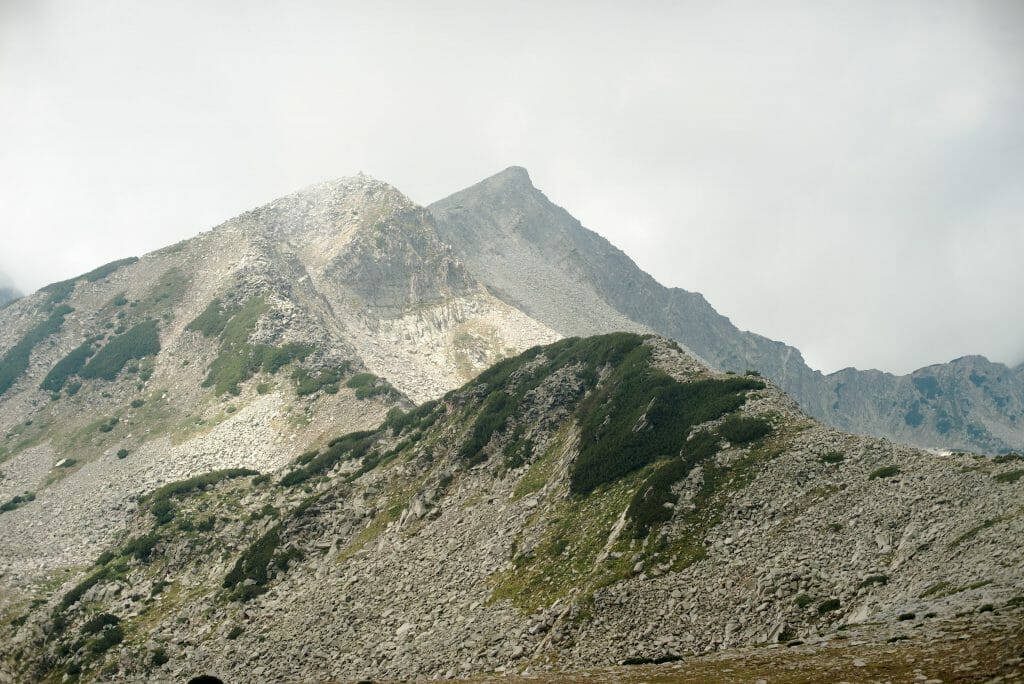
[[0, 0, 1024, 373]]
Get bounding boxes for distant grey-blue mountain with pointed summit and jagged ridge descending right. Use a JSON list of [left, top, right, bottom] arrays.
[[430, 167, 1024, 454]]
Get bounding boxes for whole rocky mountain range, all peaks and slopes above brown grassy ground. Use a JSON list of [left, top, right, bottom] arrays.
[[0, 168, 1024, 682]]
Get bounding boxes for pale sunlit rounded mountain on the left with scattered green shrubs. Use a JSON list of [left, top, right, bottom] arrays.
[[0, 176, 558, 608]]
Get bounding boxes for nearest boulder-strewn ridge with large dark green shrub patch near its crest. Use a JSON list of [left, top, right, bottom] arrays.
[[0, 333, 1024, 682]]
